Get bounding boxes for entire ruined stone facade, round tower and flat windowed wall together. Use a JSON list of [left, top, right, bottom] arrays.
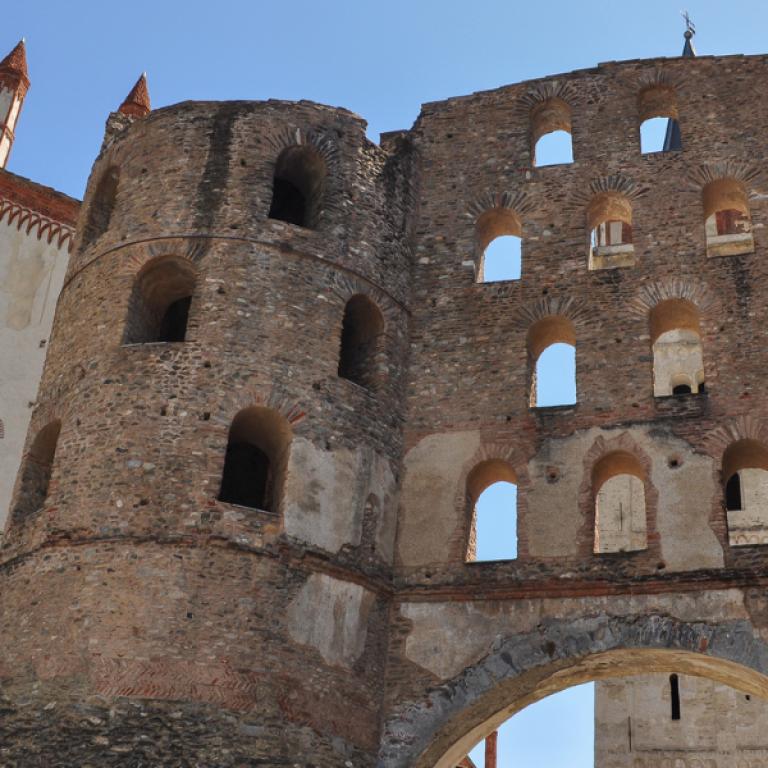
[[0, 49, 768, 768]]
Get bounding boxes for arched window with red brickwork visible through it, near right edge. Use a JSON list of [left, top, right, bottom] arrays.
[[702, 178, 755, 256]]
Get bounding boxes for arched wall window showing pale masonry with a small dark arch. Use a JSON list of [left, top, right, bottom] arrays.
[[649, 299, 704, 397]]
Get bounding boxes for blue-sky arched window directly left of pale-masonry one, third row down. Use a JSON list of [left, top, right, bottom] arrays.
[[527, 315, 577, 408]]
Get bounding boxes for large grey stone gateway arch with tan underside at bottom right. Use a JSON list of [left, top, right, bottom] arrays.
[[379, 611, 768, 768]]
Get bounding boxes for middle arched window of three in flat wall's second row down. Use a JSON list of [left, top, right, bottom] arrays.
[[587, 192, 635, 269]]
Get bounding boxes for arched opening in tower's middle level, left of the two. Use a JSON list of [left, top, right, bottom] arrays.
[[123, 256, 196, 344]]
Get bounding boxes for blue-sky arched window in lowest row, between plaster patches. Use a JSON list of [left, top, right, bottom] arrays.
[[467, 459, 517, 561]]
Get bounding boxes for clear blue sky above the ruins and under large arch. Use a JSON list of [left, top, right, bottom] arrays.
[[0, 0, 768, 768]]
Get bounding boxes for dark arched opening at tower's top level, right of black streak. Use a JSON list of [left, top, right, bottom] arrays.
[[269, 146, 326, 228]]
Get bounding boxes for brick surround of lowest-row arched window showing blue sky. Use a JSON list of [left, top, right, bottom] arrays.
[[448, 442, 531, 562]]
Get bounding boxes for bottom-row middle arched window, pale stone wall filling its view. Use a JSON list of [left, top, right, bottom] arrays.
[[592, 451, 648, 554]]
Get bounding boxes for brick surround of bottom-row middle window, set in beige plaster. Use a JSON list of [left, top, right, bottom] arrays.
[[578, 432, 661, 563]]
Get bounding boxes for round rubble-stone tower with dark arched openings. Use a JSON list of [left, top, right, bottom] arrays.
[[0, 101, 410, 766]]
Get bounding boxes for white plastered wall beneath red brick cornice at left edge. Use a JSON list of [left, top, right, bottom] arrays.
[[0, 220, 68, 526]]
